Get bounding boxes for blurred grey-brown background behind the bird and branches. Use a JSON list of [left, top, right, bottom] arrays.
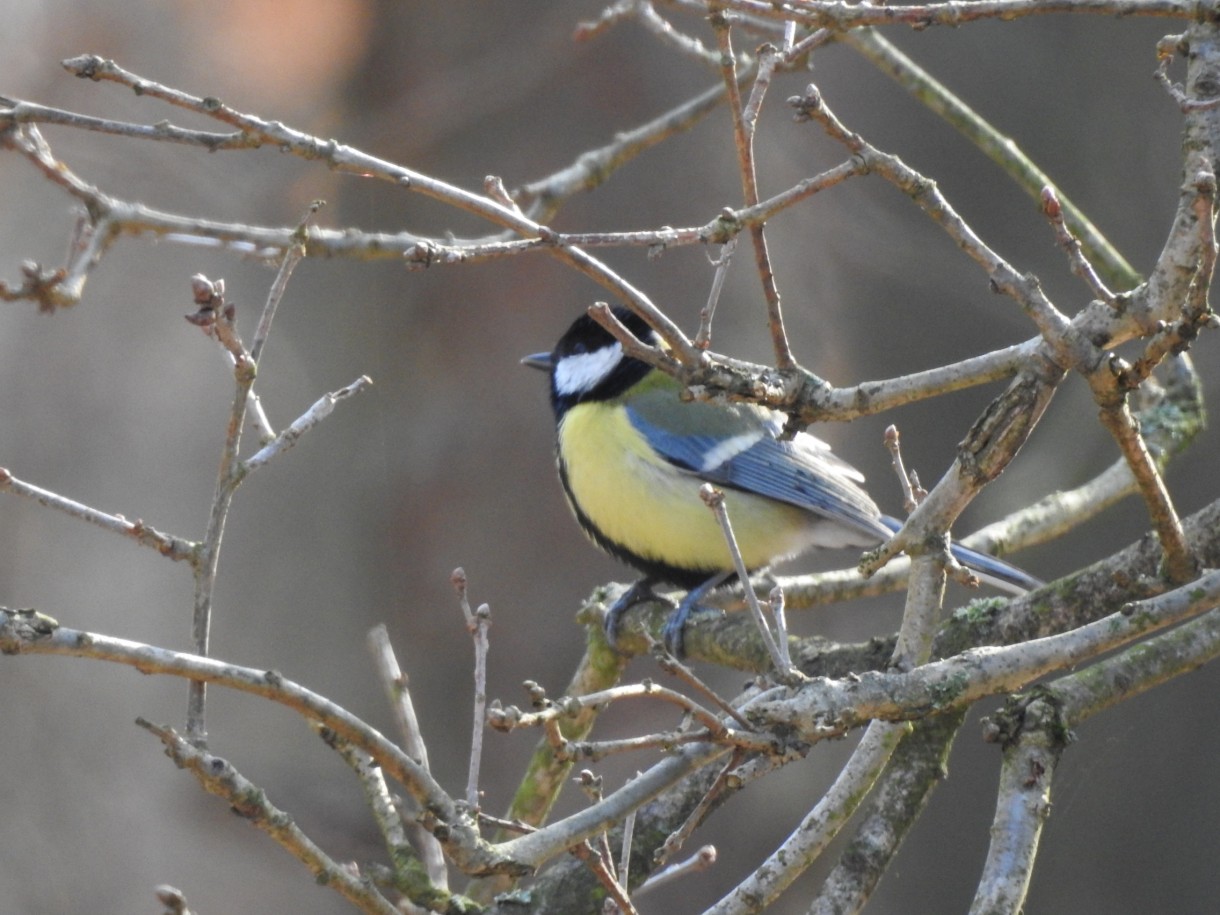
[[0, 0, 1220, 915]]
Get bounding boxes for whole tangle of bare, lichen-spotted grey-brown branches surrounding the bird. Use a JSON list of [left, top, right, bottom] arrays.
[[0, 10, 1220, 913]]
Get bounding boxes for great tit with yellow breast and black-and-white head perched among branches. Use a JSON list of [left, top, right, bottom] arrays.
[[521, 309, 1041, 655]]
